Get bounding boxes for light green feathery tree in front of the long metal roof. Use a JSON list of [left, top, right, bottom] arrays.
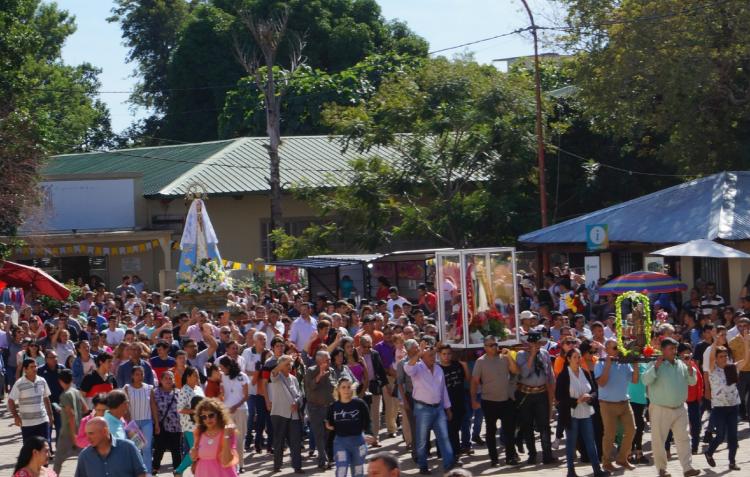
[[274, 58, 538, 258]]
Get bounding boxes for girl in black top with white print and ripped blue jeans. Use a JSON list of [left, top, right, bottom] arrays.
[[326, 377, 371, 477]]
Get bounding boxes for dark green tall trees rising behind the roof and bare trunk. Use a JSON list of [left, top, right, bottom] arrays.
[[110, 0, 428, 144]]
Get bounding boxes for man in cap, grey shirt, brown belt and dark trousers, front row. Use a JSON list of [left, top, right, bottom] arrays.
[[516, 331, 558, 464]]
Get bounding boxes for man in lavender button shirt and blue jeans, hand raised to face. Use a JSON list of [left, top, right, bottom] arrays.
[[404, 341, 458, 475]]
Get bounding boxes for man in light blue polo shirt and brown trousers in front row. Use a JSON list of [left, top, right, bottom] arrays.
[[594, 339, 638, 472]]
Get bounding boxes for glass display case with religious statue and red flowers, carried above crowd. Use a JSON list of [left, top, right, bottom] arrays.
[[435, 247, 519, 348]]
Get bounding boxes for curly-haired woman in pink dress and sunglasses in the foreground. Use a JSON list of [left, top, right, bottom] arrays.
[[190, 398, 239, 477]]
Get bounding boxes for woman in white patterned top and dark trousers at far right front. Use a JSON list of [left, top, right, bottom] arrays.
[[704, 340, 750, 470]]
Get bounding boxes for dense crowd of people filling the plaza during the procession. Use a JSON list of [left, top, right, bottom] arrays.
[[0, 268, 750, 477]]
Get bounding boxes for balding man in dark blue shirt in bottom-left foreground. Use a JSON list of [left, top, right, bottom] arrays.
[[75, 417, 146, 477]]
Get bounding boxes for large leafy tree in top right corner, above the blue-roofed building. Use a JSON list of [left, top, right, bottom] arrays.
[[565, 0, 750, 174]]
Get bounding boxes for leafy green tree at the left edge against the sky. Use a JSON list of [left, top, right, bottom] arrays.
[[0, 0, 111, 235]]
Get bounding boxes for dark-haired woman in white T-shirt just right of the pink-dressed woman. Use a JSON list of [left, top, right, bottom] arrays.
[[219, 355, 250, 473]]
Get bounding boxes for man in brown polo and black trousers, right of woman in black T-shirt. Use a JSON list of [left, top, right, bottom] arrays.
[[470, 336, 520, 467]]
